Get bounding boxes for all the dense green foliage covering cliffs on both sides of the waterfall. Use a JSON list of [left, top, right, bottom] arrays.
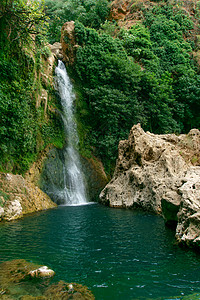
[[0, 0, 200, 172]]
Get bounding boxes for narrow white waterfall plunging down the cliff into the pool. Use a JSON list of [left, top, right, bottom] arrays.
[[54, 61, 87, 205]]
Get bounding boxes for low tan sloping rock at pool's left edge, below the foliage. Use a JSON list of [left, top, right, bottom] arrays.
[[0, 173, 56, 221]]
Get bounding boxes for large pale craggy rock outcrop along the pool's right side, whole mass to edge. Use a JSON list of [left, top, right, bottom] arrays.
[[100, 124, 200, 246]]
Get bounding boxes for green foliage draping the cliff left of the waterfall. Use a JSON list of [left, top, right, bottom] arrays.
[[0, 0, 64, 172]]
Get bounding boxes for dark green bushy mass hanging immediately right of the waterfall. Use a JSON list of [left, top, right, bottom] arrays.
[[76, 23, 141, 163]]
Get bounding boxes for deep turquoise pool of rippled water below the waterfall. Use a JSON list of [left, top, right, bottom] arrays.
[[0, 204, 200, 300]]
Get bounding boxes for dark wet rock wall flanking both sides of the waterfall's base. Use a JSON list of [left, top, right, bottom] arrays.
[[39, 148, 108, 204]]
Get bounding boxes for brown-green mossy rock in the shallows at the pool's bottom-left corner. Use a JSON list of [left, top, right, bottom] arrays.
[[0, 259, 94, 300]]
